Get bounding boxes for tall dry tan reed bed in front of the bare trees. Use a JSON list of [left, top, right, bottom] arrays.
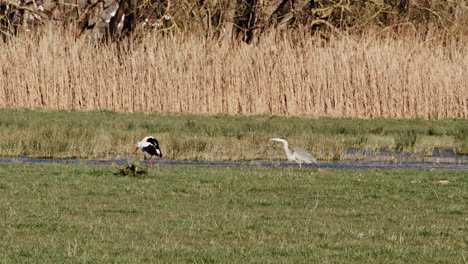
[[0, 31, 468, 119]]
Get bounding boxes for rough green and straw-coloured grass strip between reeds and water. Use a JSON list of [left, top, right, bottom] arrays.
[[0, 109, 468, 160]]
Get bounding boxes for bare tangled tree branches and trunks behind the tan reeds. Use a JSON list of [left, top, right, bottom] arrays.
[[0, 0, 468, 43]]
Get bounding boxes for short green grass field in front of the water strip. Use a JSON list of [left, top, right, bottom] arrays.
[[0, 164, 468, 263]]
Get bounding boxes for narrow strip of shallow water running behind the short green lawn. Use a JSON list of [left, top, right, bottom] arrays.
[[0, 157, 468, 170]]
